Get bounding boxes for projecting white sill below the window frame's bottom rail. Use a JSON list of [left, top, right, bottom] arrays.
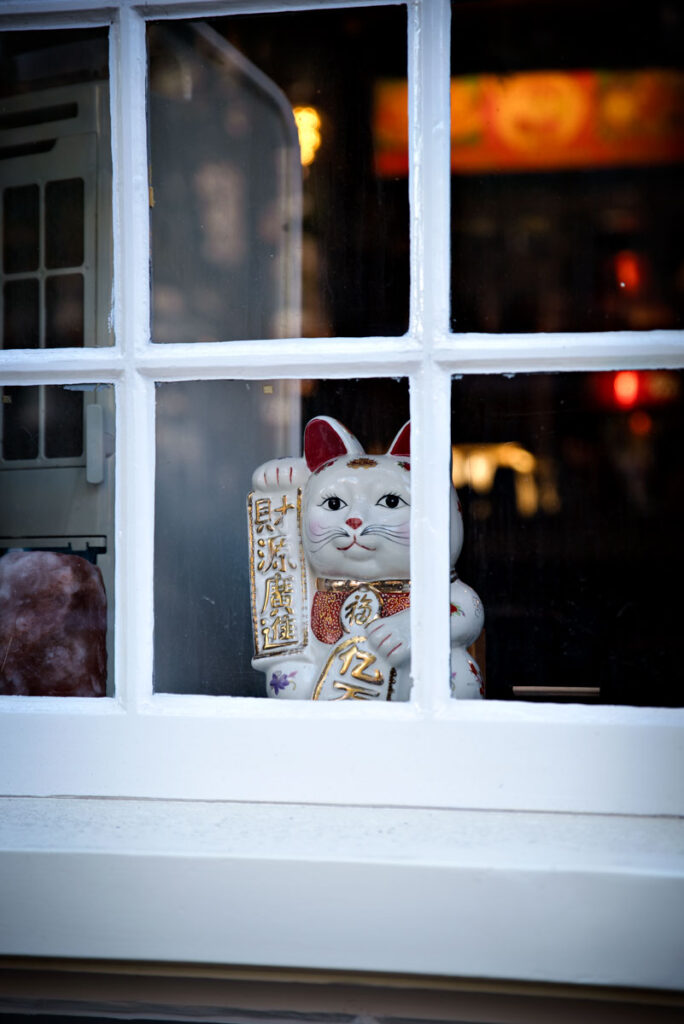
[[0, 800, 684, 989]]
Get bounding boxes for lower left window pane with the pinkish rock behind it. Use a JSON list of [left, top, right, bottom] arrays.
[[0, 385, 115, 696]]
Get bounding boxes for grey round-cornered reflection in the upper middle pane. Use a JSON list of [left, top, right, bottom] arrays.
[[148, 23, 302, 342]]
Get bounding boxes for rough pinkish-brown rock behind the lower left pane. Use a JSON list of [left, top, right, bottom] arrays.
[[0, 551, 106, 697]]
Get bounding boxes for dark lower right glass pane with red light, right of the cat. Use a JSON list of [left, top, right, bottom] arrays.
[[452, 371, 684, 707]]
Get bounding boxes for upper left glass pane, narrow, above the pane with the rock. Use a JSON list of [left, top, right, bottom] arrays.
[[0, 29, 113, 348]]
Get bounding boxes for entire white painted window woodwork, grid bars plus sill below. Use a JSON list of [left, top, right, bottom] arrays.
[[0, 0, 684, 987]]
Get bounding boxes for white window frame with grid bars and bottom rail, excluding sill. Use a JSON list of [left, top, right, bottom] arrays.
[[0, 0, 684, 984]]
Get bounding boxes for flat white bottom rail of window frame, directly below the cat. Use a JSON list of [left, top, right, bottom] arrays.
[[0, 700, 684, 814]]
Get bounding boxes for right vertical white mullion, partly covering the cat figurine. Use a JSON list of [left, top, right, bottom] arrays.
[[409, 0, 451, 710]]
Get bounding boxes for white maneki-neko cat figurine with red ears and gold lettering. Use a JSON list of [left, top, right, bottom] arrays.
[[248, 416, 484, 700]]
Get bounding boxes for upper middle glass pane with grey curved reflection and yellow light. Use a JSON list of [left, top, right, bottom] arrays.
[[148, 6, 409, 342]]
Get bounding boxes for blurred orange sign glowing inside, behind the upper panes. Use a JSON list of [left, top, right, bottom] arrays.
[[374, 70, 684, 177]]
